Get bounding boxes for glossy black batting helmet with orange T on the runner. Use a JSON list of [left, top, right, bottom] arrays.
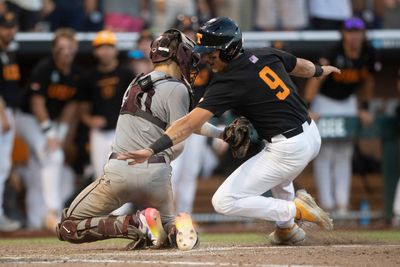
[[194, 17, 243, 62]]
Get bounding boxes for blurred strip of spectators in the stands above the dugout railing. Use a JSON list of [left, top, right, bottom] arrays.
[[0, 0, 400, 32]]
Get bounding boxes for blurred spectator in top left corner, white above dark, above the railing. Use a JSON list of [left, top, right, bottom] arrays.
[[0, 0, 43, 32]]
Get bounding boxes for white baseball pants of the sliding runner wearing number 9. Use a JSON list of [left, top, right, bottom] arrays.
[[212, 121, 321, 228]]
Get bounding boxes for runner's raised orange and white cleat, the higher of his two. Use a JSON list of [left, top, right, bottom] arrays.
[[294, 189, 333, 230]]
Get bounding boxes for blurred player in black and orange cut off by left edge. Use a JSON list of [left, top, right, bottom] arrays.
[[0, 12, 21, 232]]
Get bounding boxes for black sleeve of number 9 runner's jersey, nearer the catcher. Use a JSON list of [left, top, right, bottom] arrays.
[[197, 82, 240, 117]]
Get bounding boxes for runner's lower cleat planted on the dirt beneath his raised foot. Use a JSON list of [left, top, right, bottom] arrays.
[[269, 224, 306, 245]]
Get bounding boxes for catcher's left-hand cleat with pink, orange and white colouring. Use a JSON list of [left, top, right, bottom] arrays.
[[136, 208, 167, 247]]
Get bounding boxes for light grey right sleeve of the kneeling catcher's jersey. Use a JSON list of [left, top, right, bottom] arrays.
[[167, 83, 190, 124]]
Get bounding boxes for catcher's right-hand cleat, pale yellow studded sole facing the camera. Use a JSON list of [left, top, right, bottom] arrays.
[[175, 212, 200, 250]]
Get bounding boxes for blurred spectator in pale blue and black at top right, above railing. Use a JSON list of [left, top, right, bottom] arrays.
[[309, 0, 352, 30]]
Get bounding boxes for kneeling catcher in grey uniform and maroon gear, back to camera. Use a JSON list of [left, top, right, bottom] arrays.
[[56, 29, 205, 250]]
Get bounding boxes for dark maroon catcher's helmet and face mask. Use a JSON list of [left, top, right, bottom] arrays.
[[150, 29, 200, 83]]
